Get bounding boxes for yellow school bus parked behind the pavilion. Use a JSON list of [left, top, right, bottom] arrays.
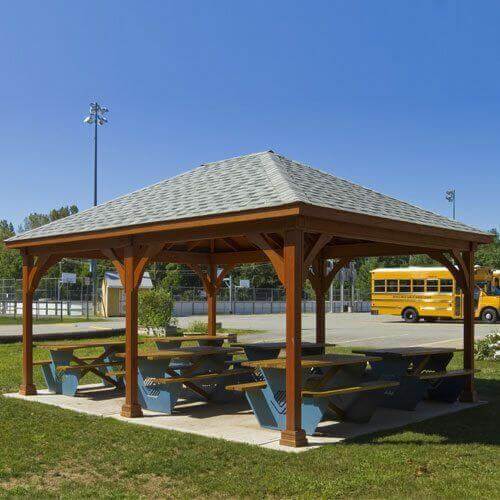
[[371, 267, 500, 323]]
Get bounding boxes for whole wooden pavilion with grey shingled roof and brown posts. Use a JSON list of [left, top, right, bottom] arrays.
[[6, 151, 492, 446]]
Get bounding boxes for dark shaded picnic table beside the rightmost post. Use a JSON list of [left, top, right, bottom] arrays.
[[353, 347, 472, 410]]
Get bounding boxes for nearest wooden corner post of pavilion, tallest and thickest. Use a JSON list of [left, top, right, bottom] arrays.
[[280, 229, 307, 447]]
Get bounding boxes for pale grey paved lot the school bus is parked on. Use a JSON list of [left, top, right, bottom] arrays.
[[179, 313, 494, 347]]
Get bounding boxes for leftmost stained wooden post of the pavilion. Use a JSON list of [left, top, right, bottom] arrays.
[[19, 255, 36, 396]]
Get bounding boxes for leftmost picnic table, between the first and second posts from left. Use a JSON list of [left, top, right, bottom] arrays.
[[33, 340, 132, 396]]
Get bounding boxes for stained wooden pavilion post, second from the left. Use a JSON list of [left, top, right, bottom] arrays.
[[121, 246, 142, 418]]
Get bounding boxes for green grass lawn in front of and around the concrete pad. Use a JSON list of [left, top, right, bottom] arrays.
[[0, 338, 500, 498]]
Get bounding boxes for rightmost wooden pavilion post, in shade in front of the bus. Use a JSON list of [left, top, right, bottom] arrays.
[[460, 250, 478, 402]]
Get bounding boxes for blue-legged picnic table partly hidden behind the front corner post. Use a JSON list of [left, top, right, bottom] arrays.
[[226, 354, 398, 435]]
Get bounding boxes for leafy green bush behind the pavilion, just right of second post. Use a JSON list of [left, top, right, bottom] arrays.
[[139, 287, 175, 330]]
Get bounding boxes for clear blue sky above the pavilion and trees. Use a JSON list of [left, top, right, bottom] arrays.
[[0, 0, 500, 229]]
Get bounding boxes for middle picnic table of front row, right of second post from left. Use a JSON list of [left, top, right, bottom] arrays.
[[118, 346, 253, 415]]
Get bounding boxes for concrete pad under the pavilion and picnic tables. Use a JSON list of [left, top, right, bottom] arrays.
[[4, 384, 485, 453]]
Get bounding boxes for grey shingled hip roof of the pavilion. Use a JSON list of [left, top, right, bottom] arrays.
[[8, 151, 483, 241]]
